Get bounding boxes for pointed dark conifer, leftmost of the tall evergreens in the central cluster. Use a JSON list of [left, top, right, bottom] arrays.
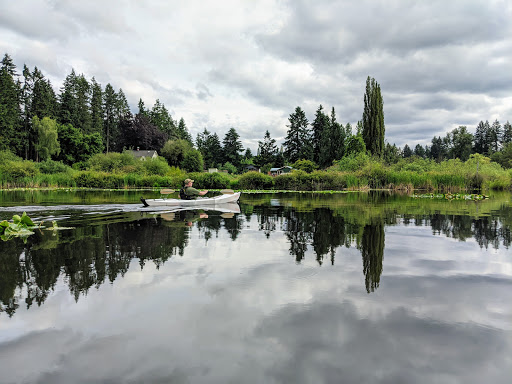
[[284, 107, 313, 163]]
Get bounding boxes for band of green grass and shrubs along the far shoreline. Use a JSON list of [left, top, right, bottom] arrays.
[[0, 151, 512, 192]]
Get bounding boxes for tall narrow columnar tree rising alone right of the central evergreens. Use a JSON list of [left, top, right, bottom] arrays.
[[362, 76, 385, 156]]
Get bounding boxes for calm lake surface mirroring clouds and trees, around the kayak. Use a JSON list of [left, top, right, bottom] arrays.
[[0, 191, 512, 384]]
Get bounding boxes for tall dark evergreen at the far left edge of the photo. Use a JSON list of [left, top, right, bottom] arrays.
[[0, 54, 25, 155]]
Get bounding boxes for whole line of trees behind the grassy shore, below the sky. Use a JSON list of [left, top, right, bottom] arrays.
[[0, 54, 512, 173]]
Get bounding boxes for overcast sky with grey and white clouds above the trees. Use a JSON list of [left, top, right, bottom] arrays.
[[0, 0, 512, 151]]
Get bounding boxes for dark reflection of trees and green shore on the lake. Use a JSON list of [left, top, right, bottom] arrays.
[[0, 193, 512, 316]]
